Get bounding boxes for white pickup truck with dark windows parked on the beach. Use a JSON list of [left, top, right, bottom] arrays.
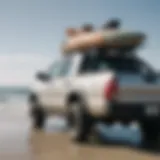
[[29, 25, 160, 145]]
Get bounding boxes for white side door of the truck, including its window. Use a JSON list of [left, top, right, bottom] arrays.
[[48, 57, 72, 112]]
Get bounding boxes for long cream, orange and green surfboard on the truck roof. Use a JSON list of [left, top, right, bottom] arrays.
[[62, 30, 146, 53]]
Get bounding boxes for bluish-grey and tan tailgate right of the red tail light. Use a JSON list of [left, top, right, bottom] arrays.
[[117, 74, 160, 103]]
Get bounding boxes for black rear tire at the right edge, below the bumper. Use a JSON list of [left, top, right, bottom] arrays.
[[141, 121, 160, 149]]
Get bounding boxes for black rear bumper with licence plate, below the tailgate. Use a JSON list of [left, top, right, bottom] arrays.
[[105, 102, 160, 121]]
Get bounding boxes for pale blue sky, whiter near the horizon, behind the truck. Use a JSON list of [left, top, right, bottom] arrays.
[[0, 0, 160, 85]]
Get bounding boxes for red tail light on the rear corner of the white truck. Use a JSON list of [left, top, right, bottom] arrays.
[[104, 79, 119, 100]]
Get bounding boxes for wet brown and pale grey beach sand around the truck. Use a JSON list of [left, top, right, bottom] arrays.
[[0, 102, 160, 160]]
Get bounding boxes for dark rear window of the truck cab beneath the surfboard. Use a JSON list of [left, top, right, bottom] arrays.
[[81, 55, 142, 73]]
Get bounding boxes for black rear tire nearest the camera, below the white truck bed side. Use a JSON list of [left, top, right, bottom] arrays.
[[68, 102, 93, 142]]
